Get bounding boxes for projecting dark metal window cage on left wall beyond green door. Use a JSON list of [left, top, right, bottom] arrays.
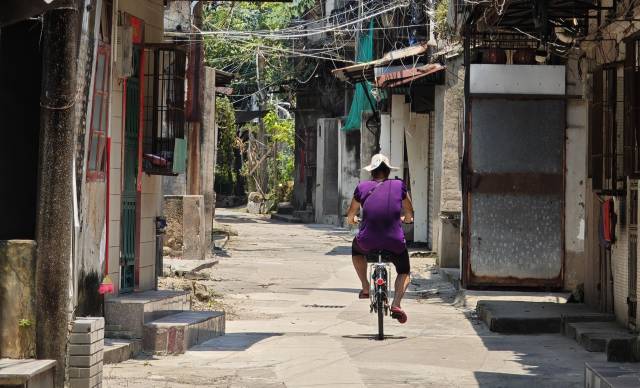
[[143, 45, 186, 175]]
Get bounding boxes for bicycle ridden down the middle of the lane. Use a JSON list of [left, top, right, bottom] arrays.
[[366, 250, 393, 341]]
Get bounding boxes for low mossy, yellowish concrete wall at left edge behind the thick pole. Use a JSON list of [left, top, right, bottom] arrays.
[[0, 240, 36, 358]]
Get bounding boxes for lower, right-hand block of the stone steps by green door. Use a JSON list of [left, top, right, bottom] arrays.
[[142, 311, 225, 355]]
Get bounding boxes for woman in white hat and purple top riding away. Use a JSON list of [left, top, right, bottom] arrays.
[[347, 154, 413, 323]]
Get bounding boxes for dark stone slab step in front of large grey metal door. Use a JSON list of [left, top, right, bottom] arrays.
[[476, 300, 593, 334]]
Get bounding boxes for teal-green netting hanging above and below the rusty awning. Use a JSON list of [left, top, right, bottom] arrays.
[[342, 19, 373, 132]]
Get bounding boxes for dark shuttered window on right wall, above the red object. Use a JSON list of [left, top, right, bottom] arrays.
[[589, 66, 626, 195]]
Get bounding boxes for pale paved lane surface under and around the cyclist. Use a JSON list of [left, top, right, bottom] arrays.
[[104, 209, 604, 388]]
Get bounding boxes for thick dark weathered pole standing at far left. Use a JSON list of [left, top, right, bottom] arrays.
[[36, 0, 79, 388]]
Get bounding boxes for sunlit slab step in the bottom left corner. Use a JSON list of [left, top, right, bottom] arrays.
[[0, 359, 56, 388]]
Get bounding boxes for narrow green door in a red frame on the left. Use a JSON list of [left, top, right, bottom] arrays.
[[120, 49, 140, 293]]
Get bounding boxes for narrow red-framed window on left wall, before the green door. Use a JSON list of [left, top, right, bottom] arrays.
[[87, 42, 111, 180]]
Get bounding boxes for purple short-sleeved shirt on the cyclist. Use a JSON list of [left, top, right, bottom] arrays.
[[353, 179, 407, 254]]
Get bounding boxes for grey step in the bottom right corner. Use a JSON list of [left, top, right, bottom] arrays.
[[584, 362, 640, 388]]
